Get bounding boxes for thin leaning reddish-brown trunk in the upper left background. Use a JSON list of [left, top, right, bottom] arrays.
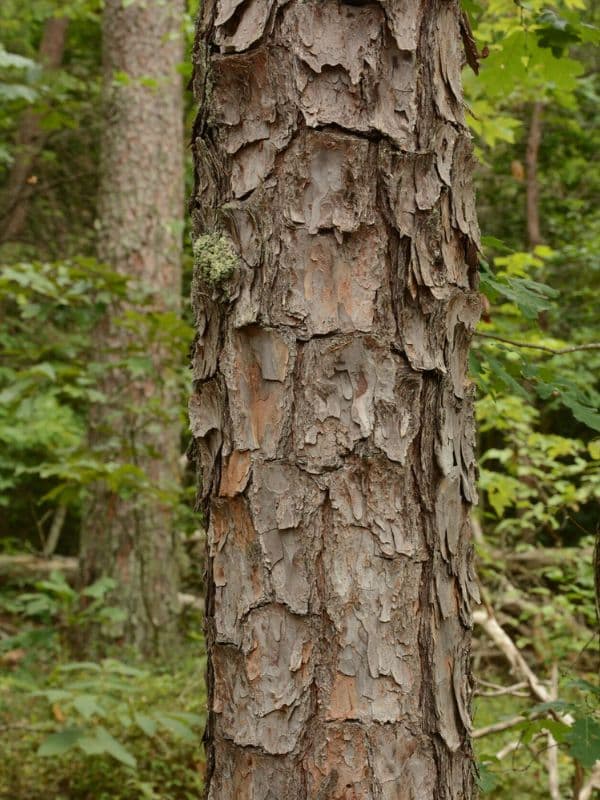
[[0, 17, 69, 242]]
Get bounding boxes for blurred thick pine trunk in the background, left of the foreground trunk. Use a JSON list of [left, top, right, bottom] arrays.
[[82, 0, 183, 652]]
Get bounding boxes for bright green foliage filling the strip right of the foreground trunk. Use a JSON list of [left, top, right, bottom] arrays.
[[465, 0, 600, 799]]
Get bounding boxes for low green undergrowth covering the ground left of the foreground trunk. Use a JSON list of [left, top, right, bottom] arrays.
[[0, 578, 206, 800]]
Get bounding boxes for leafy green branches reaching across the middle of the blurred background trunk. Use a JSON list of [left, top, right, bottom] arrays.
[[0, 257, 191, 552]]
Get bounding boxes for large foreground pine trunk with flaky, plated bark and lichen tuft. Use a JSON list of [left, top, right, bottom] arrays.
[[190, 0, 479, 800]]
